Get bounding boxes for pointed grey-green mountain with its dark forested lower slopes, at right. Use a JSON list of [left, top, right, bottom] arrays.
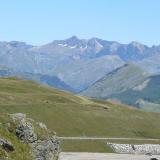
[[81, 64, 160, 112]]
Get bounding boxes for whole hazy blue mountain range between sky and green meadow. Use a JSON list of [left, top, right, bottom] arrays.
[[0, 36, 160, 111]]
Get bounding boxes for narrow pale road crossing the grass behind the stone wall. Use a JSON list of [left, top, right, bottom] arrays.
[[59, 137, 160, 141]]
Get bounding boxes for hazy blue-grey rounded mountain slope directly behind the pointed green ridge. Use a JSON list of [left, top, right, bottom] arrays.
[[55, 55, 124, 92]]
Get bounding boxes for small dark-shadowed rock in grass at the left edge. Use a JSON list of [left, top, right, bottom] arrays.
[[0, 138, 15, 152]]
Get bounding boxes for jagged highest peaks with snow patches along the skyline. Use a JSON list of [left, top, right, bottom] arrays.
[[30, 36, 160, 61]]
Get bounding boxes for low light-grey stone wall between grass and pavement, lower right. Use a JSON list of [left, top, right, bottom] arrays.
[[107, 143, 160, 155]]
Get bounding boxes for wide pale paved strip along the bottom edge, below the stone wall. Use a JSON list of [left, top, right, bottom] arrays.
[[59, 152, 160, 160]]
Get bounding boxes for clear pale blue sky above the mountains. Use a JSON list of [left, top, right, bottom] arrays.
[[0, 0, 160, 46]]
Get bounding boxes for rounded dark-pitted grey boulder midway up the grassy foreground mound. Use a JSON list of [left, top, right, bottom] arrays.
[[16, 121, 37, 143]]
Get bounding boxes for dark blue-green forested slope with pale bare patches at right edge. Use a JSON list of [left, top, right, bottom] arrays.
[[112, 75, 160, 111]]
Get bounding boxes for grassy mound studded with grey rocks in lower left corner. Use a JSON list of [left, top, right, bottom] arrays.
[[0, 113, 60, 160]]
